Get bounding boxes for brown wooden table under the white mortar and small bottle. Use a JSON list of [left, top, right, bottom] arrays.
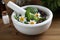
[[0, 18, 60, 40]]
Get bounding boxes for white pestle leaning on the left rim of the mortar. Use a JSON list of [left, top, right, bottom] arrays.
[[7, 1, 26, 15]]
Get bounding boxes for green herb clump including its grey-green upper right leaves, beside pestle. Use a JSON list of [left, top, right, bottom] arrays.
[[25, 7, 38, 21]]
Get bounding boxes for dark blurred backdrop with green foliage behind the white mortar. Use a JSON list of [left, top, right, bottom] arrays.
[[0, 0, 60, 18]]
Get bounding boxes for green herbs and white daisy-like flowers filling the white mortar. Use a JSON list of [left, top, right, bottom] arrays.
[[14, 7, 46, 25]]
